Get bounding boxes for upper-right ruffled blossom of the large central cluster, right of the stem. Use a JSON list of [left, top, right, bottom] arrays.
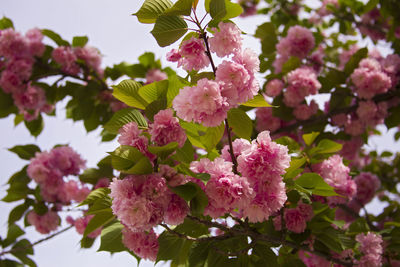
[[238, 131, 290, 182]]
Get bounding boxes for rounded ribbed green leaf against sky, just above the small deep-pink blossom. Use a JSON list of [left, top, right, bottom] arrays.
[[151, 15, 188, 47]]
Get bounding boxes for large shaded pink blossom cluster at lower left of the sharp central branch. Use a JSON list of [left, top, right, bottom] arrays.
[[110, 174, 189, 232]]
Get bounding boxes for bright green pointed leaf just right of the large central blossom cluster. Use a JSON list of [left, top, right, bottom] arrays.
[[295, 173, 338, 196]]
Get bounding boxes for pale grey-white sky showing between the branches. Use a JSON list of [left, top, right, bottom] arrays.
[[0, 0, 399, 267]]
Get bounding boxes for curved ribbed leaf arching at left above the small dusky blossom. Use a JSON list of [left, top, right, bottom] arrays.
[[104, 108, 148, 134]]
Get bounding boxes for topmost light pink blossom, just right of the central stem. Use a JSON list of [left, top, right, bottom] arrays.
[[209, 22, 242, 57]]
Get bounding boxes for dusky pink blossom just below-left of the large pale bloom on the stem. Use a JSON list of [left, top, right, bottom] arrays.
[[149, 109, 186, 147]]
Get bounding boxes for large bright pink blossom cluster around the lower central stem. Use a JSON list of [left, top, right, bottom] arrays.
[[190, 131, 290, 222]]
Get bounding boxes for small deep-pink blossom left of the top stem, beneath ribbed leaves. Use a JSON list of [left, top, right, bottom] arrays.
[[177, 37, 210, 71]]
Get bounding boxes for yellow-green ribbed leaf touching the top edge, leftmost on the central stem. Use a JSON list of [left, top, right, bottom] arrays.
[[132, 0, 172, 23]]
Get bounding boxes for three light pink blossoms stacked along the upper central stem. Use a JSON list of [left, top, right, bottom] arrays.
[[168, 22, 260, 127]]
